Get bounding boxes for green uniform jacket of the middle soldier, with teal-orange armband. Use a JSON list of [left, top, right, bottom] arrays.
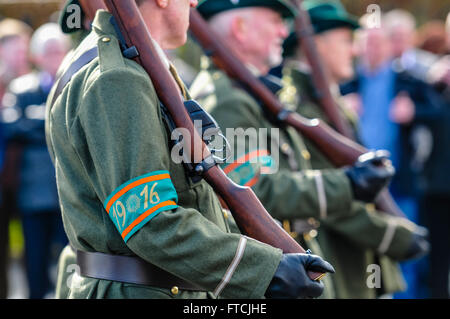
[[190, 63, 366, 298]]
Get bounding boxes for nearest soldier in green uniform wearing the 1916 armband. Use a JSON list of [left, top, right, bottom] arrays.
[[46, 0, 334, 298]]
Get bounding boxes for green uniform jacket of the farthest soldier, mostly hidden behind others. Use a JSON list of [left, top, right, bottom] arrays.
[[280, 64, 415, 298]]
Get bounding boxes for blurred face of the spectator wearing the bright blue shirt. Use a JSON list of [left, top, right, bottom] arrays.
[[358, 28, 392, 70]]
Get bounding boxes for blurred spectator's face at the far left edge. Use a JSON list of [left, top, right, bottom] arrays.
[[0, 36, 30, 77]]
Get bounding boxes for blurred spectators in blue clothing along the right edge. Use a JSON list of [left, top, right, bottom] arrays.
[[341, 9, 450, 298]]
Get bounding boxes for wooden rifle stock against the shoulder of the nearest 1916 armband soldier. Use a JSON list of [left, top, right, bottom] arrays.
[[99, 0, 323, 280]]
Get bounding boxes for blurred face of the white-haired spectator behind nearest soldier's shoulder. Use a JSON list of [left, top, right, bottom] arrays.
[[33, 40, 69, 76]]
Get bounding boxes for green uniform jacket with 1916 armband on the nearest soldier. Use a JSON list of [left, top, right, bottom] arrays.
[[46, 11, 282, 298]]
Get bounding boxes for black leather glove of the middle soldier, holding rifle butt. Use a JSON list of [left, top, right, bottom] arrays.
[[344, 151, 395, 203]]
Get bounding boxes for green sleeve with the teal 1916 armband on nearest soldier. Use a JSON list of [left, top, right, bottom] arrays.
[[74, 61, 282, 298]]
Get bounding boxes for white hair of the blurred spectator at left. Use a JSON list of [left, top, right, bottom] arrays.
[[30, 23, 69, 56]]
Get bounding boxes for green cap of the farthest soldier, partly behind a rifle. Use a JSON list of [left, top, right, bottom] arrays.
[[283, 0, 359, 57]]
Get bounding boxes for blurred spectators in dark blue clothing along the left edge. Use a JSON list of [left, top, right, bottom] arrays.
[[0, 18, 70, 298]]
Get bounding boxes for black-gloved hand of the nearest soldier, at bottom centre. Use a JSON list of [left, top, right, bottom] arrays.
[[265, 254, 335, 299]]
